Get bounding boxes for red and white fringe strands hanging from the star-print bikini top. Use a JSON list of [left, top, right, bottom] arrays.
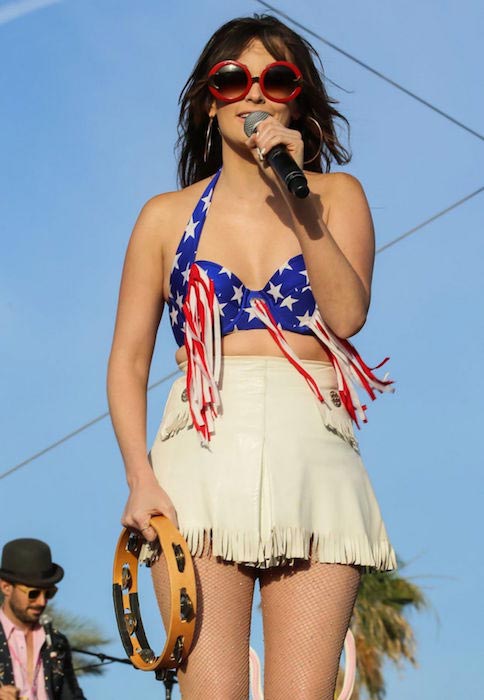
[[183, 265, 393, 446]]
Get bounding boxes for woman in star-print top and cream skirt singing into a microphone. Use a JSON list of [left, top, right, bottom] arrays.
[[108, 16, 396, 700]]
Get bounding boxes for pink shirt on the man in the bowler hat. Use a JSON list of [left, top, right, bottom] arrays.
[[0, 608, 49, 700]]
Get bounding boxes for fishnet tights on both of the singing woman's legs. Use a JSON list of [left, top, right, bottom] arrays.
[[152, 556, 360, 700]]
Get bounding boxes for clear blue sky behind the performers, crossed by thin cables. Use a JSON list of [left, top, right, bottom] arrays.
[[0, 0, 484, 700]]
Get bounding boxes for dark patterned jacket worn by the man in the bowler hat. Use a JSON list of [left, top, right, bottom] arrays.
[[0, 624, 86, 700]]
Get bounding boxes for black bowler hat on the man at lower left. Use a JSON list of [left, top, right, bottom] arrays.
[[0, 537, 64, 588]]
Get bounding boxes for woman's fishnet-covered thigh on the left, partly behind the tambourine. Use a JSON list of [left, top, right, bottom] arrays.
[[152, 555, 255, 700]]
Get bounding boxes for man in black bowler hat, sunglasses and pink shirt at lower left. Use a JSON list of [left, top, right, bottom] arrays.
[[0, 538, 85, 700]]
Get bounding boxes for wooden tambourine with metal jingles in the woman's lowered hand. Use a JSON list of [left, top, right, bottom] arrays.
[[113, 515, 197, 671]]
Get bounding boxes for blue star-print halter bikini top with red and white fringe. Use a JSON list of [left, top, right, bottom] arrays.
[[167, 170, 392, 445]]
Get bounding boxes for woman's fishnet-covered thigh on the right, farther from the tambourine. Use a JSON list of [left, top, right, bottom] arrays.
[[260, 561, 361, 700]]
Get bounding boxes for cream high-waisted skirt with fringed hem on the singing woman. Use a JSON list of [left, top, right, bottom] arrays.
[[150, 356, 396, 570]]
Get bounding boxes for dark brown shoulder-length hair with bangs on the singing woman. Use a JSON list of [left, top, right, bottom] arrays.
[[177, 15, 351, 187]]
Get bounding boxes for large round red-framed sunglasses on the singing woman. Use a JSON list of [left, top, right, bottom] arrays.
[[208, 61, 302, 102]]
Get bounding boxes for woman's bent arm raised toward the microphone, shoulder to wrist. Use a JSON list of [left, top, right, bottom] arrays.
[[284, 173, 375, 338]]
